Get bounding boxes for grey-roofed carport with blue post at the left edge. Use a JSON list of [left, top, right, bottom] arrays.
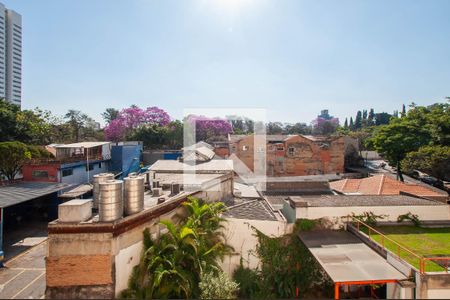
[[0, 182, 71, 263]]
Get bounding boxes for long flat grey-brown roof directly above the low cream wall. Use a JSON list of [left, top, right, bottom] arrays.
[[287, 195, 447, 207]]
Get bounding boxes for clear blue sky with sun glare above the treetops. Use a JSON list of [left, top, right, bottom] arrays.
[[0, 0, 450, 123]]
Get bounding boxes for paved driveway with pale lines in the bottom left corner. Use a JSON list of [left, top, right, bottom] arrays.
[[0, 241, 47, 299]]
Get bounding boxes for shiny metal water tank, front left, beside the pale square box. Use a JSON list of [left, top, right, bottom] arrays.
[[98, 180, 123, 222]]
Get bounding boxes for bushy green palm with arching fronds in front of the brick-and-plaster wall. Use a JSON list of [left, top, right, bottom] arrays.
[[121, 198, 232, 299]]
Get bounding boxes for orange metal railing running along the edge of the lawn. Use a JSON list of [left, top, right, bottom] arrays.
[[347, 216, 450, 274]]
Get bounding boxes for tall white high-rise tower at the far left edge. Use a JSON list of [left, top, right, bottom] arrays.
[[0, 3, 22, 106]]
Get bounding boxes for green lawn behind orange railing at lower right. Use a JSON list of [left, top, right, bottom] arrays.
[[364, 226, 450, 272]]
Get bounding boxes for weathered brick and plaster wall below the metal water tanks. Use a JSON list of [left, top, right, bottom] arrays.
[[46, 193, 207, 299]]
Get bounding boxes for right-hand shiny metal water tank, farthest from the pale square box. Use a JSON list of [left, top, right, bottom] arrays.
[[123, 175, 145, 216]]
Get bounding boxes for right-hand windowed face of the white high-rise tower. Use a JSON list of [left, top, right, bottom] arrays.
[[5, 9, 22, 106]]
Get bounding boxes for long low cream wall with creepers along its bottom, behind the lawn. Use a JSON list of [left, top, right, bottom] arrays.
[[296, 205, 450, 224]]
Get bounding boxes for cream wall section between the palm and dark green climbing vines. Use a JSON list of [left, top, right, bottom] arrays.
[[221, 218, 292, 276]]
